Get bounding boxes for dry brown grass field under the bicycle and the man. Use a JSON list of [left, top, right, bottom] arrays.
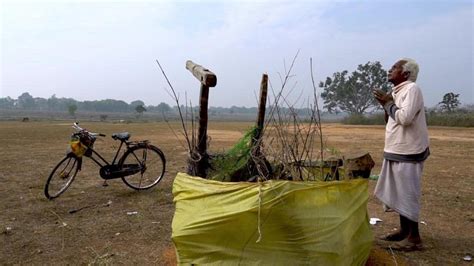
[[0, 122, 474, 265]]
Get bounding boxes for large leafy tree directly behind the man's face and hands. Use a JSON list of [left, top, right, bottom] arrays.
[[319, 62, 390, 115]]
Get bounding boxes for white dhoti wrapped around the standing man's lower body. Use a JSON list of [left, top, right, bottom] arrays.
[[374, 159, 423, 222]]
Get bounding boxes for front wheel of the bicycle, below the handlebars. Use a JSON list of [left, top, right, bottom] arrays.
[[44, 156, 79, 200]]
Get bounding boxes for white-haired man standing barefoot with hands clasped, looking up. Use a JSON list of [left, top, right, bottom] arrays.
[[373, 59, 430, 251]]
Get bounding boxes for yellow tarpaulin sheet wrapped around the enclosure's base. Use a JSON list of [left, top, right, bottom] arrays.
[[172, 173, 373, 265]]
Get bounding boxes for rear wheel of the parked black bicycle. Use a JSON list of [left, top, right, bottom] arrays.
[[119, 144, 166, 190]]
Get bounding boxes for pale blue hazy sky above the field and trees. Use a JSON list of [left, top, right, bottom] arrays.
[[0, 0, 474, 107]]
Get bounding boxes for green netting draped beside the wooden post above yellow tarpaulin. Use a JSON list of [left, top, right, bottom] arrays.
[[208, 127, 258, 181]]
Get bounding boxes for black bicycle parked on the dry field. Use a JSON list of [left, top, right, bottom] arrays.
[[44, 123, 166, 200]]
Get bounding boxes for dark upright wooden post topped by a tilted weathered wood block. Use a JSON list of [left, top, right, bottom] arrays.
[[186, 60, 217, 178]]
